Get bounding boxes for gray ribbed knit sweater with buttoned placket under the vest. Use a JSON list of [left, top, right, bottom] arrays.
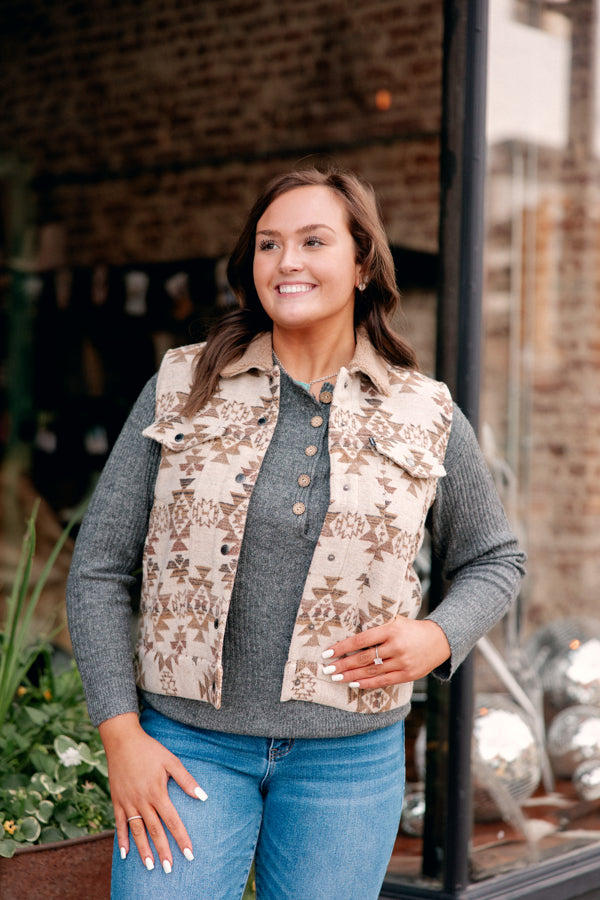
[[67, 373, 524, 738]]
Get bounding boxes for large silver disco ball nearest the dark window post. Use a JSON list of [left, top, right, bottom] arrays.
[[472, 694, 542, 822]]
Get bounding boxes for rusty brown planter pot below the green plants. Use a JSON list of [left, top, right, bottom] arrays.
[[0, 831, 114, 900]]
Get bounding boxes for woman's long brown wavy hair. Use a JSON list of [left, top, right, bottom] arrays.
[[183, 168, 417, 415]]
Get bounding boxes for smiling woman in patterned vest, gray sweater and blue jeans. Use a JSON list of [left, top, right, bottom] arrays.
[[68, 169, 523, 900]]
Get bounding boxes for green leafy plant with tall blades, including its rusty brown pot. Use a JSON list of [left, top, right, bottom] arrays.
[[0, 505, 114, 900]]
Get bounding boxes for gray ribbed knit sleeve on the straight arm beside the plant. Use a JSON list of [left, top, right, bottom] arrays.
[[67, 376, 160, 725]]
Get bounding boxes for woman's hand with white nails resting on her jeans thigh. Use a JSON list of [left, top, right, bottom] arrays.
[[99, 713, 206, 873]]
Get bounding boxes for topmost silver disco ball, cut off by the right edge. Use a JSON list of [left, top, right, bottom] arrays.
[[526, 616, 600, 716]]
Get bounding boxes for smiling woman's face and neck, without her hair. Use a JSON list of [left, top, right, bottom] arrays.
[[254, 185, 363, 386]]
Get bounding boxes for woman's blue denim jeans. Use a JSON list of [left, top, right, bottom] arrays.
[[111, 710, 404, 900]]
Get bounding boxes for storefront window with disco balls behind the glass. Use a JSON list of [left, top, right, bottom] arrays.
[[384, 0, 600, 898]]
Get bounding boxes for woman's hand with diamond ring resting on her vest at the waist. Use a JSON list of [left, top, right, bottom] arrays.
[[323, 616, 451, 690]]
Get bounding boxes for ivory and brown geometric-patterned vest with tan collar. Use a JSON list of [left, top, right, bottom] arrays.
[[136, 331, 452, 713]]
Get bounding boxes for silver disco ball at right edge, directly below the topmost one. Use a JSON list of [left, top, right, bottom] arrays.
[[548, 705, 600, 778]]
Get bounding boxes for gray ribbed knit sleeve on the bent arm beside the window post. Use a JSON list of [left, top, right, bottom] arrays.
[[427, 406, 525, 678]]
